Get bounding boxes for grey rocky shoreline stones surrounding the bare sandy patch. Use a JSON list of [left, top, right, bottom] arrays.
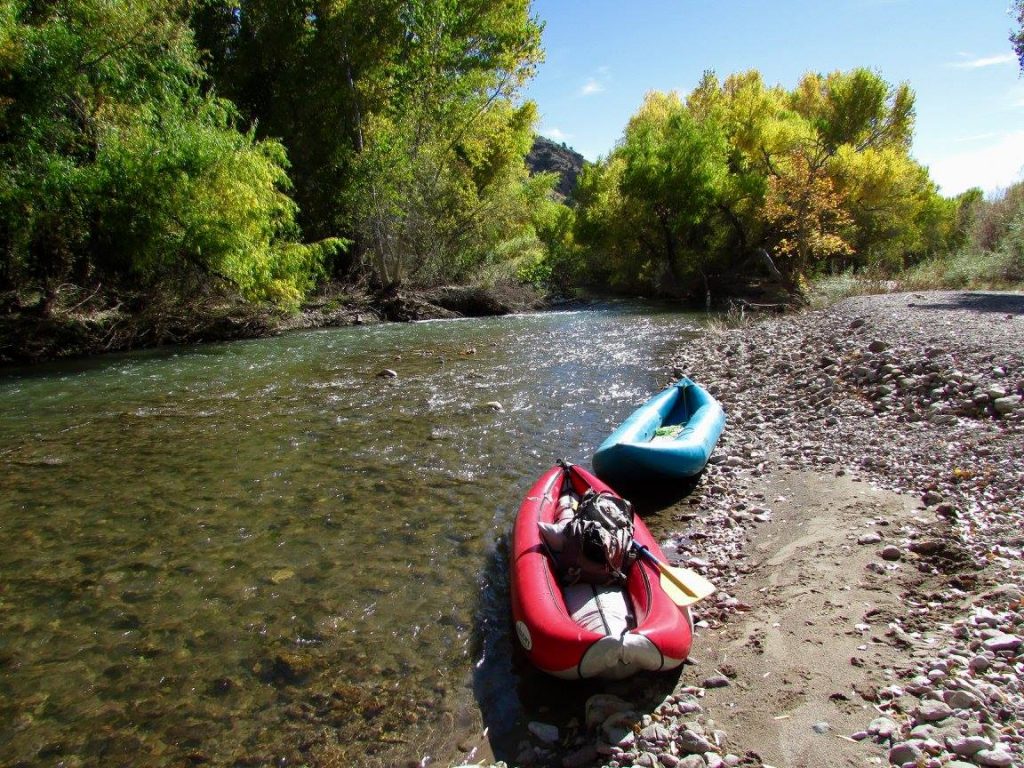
[[471, 292, 1024, 768]]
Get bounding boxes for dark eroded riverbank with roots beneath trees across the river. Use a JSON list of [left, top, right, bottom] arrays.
[[0, 284, 550, 373]]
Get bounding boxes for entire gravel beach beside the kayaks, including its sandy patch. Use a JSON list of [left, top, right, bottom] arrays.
[[473, 292, 1024, 768]]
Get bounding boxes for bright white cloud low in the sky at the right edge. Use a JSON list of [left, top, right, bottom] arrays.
[[923, 130, 1024, 197]]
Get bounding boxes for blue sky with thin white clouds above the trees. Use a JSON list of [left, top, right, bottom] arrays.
[[525, 0, 1024, 196]]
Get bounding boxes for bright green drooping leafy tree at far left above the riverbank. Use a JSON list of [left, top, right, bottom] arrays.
[[0, 0, 340, 313]]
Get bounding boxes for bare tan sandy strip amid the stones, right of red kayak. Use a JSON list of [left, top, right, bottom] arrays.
[[694, 471, 921, 766]]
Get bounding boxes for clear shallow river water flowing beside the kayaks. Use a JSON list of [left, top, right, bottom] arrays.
[[0, 306, 700, 766]]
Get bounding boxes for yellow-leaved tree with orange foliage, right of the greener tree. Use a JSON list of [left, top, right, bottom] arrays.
[[687, 69, 951, 286]]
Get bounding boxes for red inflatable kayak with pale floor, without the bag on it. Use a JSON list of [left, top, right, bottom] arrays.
[[510, 465, 692, 679]]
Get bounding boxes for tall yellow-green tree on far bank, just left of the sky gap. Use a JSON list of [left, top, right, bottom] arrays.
[[350, 0, 541, 286]]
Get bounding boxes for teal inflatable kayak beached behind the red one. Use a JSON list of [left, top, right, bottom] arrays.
[[593, 378, 725, 488]]
